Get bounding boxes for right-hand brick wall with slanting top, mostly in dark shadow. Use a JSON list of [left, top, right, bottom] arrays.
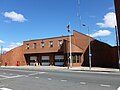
[[72, 31, 118, 68]]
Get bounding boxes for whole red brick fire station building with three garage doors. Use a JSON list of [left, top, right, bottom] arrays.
[[1, 30, 118, 68]]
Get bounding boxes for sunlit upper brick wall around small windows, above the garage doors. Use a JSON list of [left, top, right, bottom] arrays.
[[23, 36, 69, 53]]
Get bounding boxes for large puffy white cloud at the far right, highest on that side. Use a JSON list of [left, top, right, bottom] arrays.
[[96, 12, 117, 28]]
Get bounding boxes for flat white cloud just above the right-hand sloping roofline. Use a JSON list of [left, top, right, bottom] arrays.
[[90, 30, 111, 37]]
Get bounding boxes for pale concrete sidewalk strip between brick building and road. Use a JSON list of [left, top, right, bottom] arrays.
[[1, 66, 119, 72]]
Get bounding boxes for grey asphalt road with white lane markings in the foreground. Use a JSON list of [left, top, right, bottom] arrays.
[[0, 68, 120, 90]]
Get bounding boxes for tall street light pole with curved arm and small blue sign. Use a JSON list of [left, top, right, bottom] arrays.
[[82, 24, 92, 70]]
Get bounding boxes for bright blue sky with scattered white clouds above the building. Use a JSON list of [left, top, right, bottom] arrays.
[[0, 0, 116, 50]]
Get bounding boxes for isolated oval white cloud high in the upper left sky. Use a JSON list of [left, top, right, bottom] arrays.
[[4, 11, 26, 22]]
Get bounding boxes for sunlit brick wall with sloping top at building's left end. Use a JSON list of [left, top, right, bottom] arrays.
[[2, 46, 26, 66]]
